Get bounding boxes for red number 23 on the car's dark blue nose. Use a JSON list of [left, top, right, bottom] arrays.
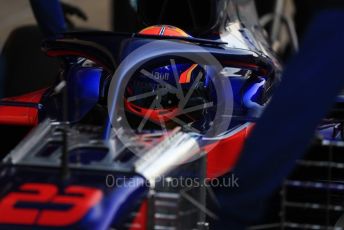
[[0, 183, 103, 227]]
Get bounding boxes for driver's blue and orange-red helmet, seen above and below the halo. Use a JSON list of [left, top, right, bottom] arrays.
[[124, 25, 216, 131]]
